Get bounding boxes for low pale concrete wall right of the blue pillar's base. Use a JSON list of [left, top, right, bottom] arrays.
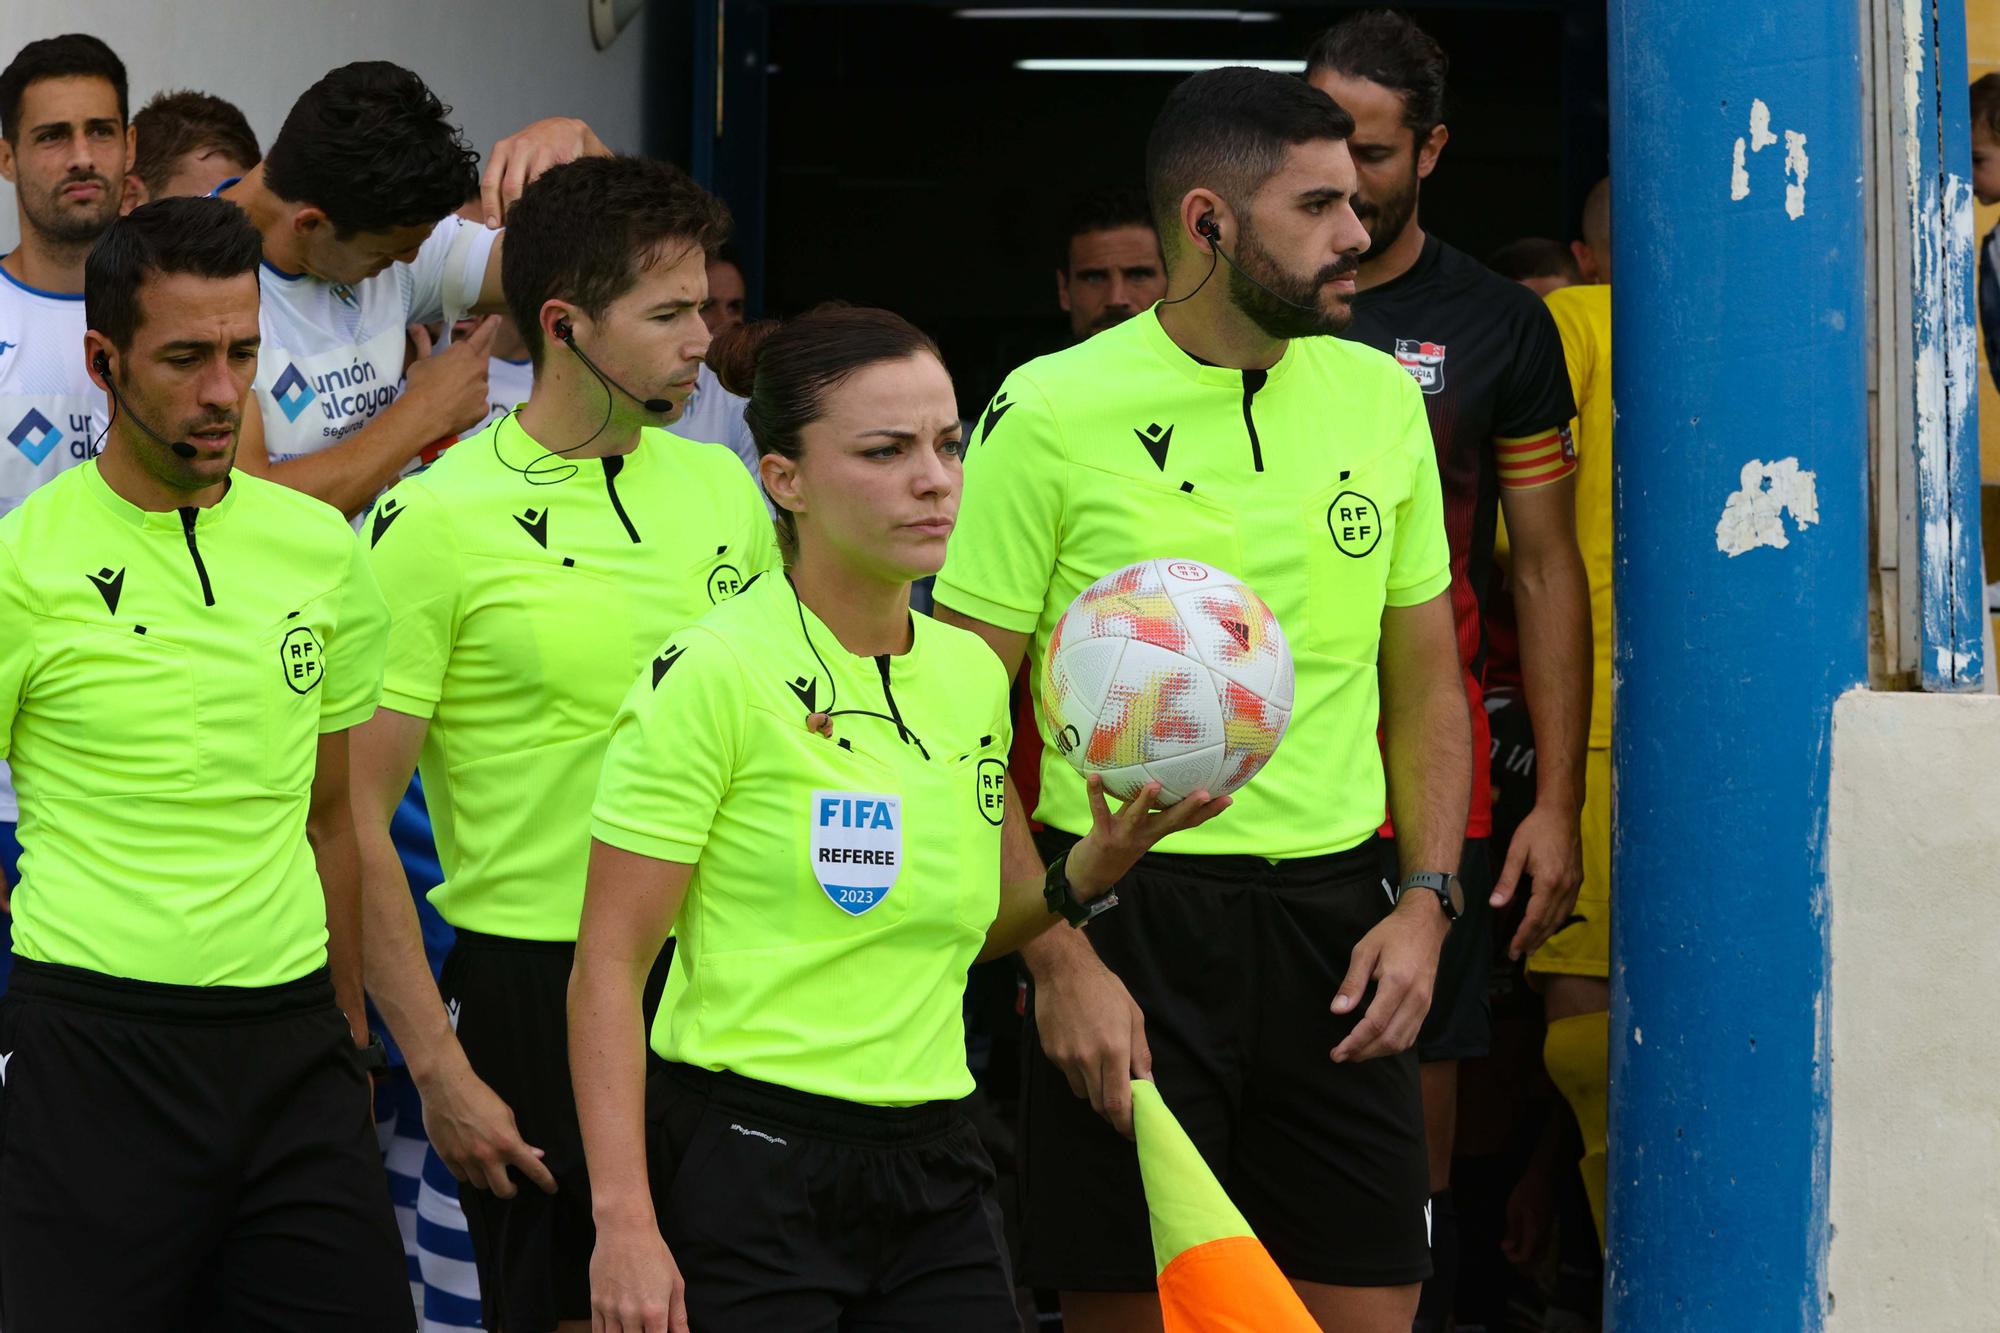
[[1832, 691, 2000, 1333]]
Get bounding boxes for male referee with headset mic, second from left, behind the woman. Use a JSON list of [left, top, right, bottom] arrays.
[[354, 158, 778, 1333]]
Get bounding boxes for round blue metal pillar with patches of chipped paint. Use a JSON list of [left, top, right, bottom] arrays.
[[1606, 0, 1868, 1333]]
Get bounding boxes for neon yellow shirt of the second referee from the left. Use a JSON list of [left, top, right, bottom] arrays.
[[360, 416, 778, 941]]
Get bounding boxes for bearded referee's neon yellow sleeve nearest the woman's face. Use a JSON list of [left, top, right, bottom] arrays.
[[936, 372, 1068, 634]]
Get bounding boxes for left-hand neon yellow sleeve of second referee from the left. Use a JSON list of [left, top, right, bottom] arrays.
[[358, 480, 464, 719]]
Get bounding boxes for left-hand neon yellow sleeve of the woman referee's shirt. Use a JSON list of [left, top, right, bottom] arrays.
[[590, 624, 750, 865]]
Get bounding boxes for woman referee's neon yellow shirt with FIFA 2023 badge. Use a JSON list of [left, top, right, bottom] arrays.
[[590, 574, 1010, 1105]]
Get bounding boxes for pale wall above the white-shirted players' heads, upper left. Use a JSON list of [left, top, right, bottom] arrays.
[[0, 0, 646, 252]]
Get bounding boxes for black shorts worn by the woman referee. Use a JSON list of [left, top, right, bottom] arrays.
[[646, 1053, 1020, 1333]]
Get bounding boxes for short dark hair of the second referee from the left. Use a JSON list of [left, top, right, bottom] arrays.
[[500, 156, 730, 366]]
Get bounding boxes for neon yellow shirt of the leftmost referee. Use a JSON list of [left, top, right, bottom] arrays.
[[0, 462, 388, 987]]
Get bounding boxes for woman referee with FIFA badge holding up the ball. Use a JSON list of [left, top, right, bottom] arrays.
[[570, 306, 1228, 1333]]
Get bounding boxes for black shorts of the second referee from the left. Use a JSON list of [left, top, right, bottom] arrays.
[[438, 931, 674, 1333]]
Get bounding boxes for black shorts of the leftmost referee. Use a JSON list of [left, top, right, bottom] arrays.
[[0, 959, 416, 1333]]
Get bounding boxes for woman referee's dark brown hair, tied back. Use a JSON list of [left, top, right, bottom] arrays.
[[712, 304, 944, 544]]
